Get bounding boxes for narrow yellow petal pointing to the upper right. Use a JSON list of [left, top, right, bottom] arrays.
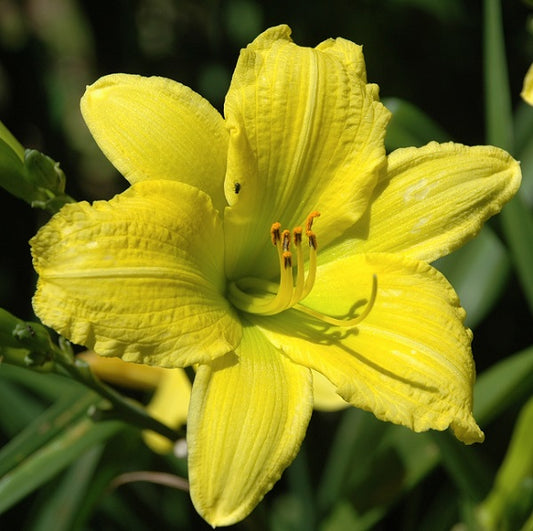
[[321, 142, 521, 262]]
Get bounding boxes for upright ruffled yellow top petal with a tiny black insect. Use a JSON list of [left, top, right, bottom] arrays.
[[225, 26, 389, 278]]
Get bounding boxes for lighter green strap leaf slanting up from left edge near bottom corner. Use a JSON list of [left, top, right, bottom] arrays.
[[0, 417, 123, 513]]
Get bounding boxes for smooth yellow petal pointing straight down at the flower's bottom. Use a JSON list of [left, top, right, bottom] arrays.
[[187, 327, 313, 527]]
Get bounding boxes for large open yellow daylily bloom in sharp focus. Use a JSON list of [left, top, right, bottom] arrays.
[[31, 26, 520, 526]]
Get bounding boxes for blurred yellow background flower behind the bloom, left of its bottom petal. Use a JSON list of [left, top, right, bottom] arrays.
[[78, 351, 191, 454]]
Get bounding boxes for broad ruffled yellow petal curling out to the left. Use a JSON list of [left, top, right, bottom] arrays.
[[31, 181, 240, 367]]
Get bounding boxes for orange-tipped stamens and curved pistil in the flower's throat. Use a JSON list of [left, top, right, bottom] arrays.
[[228, 212, 377, 327]]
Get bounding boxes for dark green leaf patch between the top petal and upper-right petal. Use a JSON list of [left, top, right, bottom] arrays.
[[383, 98, 450, 151]]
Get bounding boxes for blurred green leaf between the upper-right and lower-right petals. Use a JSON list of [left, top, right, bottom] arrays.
[[434, 225, 511, 327]]
